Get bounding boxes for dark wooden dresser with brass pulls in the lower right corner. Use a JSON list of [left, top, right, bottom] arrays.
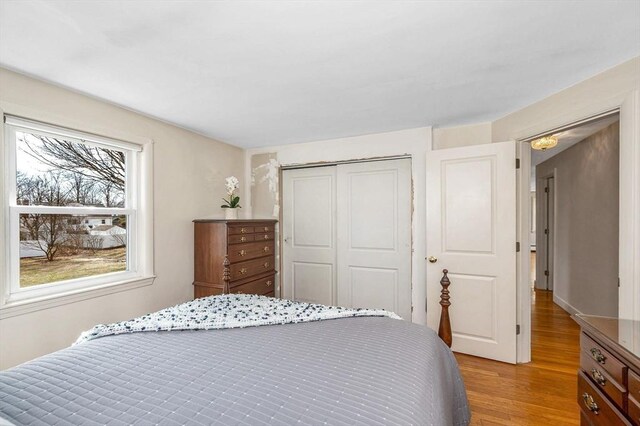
[[574, 315, 640, 426]]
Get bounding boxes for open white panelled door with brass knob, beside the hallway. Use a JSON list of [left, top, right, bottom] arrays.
[[427, 142, 516, 363]]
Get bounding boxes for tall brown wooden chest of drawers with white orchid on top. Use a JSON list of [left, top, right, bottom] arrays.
[[193, 220, 276, 298]]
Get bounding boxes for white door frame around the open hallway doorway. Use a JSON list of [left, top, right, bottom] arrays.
[[516, 90, 640, 363]]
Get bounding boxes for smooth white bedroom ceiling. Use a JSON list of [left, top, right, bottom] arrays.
[[0, 0, 640, 147]]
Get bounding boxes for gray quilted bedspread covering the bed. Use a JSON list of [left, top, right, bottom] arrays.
[[0, 317, 470, 425]]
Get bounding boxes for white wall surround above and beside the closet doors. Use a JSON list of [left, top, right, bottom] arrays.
[[245, 127, 431, 324]]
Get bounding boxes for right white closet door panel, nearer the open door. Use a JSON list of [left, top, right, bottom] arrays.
[[337, 159, 411, 321]]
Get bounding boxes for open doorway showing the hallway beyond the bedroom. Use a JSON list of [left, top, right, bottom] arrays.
[[529, 112, 620, 362]]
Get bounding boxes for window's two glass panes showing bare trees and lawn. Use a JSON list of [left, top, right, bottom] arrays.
[[16, 132, 127, 286]]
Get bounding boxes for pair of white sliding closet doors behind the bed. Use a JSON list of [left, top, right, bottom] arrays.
[[282, 159, 411, 320]]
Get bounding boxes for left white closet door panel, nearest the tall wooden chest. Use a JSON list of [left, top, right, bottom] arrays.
[[282, 166, 336, 305]]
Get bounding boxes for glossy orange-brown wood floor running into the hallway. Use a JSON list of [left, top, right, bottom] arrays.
[[456, 290, 580, 426]]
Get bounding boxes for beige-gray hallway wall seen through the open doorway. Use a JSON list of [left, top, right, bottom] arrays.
[[536, 122, 620, 317]]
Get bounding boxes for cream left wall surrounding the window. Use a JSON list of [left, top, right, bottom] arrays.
[[0, 69, 244, 369]]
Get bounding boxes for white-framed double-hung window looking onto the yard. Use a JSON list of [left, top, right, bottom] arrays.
[[3, 116, 150, 304]]
